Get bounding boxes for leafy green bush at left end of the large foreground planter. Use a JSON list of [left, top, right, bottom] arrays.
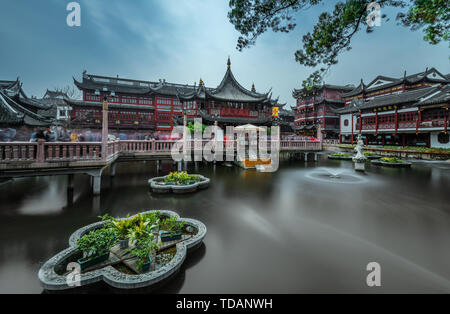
[[77, 228, 117, 258]]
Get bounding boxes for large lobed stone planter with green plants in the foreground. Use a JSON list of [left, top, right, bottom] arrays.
[[38, 211, 206, 291]]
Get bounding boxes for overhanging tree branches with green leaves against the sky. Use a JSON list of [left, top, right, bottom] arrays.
[[228, 0, 450, 88]]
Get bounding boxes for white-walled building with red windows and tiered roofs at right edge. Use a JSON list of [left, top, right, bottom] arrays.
[[338, 68, 450, 147]]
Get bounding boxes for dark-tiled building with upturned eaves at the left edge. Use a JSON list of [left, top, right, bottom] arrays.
[[0, 79, 55, 141]]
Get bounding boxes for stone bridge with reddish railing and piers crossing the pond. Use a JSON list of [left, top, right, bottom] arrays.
[[0, 140, 322, 194]]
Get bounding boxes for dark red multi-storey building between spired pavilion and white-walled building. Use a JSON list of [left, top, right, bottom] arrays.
[[292, 84, 354, 139]]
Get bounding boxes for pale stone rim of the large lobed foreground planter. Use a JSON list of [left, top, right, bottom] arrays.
[[38, 210, 207, 291]]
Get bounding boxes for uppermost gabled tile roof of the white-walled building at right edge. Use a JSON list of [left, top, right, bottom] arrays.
[[342, 68, 449, 98]]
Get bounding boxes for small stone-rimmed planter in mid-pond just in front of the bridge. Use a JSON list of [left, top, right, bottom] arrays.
[[148, 172, 210, 194]]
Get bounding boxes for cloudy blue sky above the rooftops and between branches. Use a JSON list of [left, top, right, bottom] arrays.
[[0, 0, 450, 105]]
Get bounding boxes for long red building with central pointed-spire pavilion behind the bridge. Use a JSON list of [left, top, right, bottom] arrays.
[[67, 59, 286, 137]]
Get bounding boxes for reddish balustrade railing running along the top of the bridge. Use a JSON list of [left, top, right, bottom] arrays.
[[0, 140, 322, 163]]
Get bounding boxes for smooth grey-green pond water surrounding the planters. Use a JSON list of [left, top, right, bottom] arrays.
[[0, 156, 450, 293]]
